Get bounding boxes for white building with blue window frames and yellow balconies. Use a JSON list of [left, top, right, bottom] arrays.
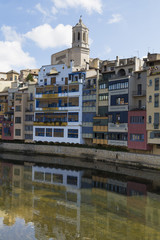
[[33, 61, 85, 144]]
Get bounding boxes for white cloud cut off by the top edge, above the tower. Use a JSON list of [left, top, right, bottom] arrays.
[[52, 0, 102, 14]]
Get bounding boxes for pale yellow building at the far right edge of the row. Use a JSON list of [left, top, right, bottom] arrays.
[[146, 54, 160, 154]]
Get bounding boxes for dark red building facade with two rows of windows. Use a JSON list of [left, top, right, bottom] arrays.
[[128, 110, 152, 150]]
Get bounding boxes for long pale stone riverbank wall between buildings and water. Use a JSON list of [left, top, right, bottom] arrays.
[[0, 142, 160, 170]]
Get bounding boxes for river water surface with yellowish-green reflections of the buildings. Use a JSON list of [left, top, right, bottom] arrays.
[[0, 159, 160, 240]]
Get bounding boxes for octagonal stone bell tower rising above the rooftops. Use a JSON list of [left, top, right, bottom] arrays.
[[72, 16, 89, 48]]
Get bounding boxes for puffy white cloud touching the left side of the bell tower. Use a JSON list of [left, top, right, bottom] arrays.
[[25, 24, 72, 49]]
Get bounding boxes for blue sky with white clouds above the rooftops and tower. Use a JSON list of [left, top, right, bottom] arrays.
[[0, 0, 160, 72]]
